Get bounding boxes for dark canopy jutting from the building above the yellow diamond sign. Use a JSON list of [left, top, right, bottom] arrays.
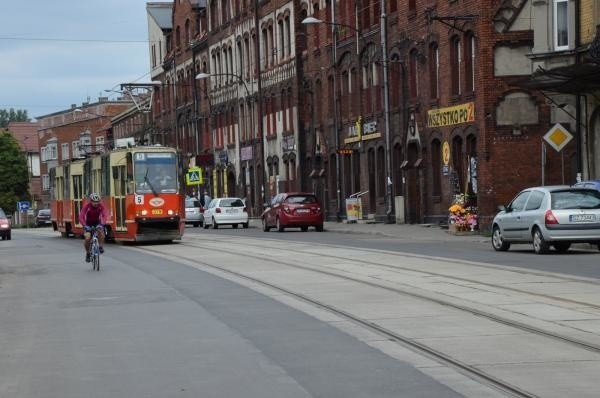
[[509, 62, 600, 94]]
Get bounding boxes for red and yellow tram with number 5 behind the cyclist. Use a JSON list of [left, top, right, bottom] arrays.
[[50, 146, 185, 242]]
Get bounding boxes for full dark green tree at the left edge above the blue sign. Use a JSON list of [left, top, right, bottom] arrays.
[[0, 131, 30, 214]]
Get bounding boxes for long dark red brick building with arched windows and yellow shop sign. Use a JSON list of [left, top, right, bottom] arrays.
[[144, 0, 600, 226]]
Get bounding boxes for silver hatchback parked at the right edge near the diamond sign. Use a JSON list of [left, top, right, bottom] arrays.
[[492, 185, 600, 254]]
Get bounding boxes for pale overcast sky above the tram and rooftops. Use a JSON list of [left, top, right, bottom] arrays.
[[0, 0, 155, 120]]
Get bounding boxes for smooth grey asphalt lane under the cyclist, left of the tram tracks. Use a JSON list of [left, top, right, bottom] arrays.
[[0, 230, 459, 398]]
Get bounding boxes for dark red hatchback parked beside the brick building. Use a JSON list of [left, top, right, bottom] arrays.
[[261, 192, 325, 232]]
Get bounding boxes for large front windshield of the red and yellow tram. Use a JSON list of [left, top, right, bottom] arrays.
[[134, 152, 178, 194]]
